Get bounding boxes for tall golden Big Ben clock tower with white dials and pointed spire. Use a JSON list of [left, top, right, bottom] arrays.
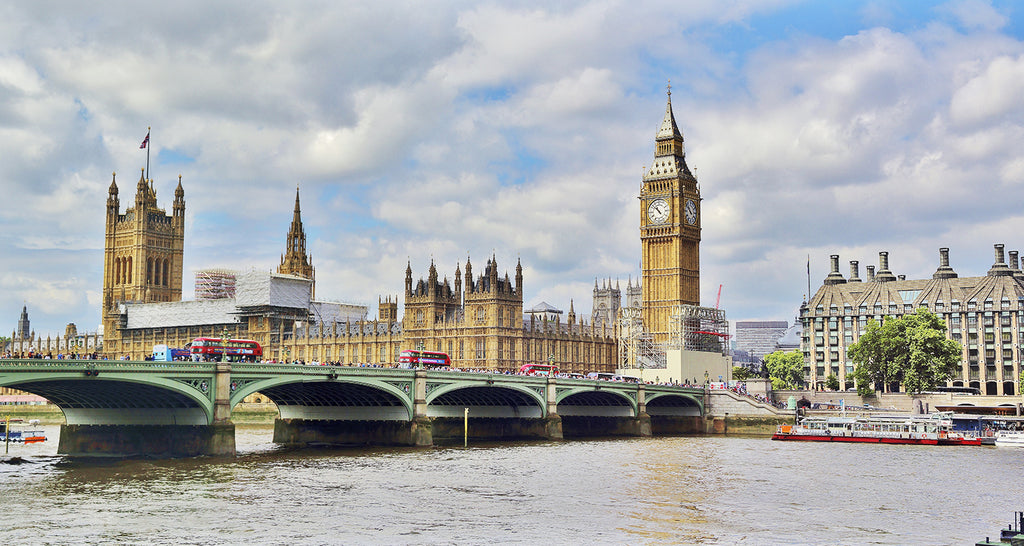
[[640, 86, 700, 342]]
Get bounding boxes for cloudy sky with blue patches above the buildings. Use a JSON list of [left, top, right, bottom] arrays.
[[0, 0, 1024, 336]]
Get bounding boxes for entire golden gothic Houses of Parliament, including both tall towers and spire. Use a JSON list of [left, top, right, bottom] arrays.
[[12, 89, 700, 372]]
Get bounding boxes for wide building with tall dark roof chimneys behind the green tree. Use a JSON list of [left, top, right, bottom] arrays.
[[801, 245, 1024, 394]]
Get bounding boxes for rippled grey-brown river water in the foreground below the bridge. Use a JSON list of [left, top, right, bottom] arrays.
[[0, 425, 1024, 545]]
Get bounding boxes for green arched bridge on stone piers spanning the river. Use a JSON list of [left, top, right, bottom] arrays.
[[0, 360, 709, 457]]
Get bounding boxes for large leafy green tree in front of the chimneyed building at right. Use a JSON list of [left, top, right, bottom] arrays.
[[847, 307, 961, 392]]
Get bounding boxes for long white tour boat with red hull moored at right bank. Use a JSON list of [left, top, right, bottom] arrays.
[[771, 412, 981, 446]]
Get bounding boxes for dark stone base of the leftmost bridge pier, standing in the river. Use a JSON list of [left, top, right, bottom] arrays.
[[57, 421, 234, 459]]
